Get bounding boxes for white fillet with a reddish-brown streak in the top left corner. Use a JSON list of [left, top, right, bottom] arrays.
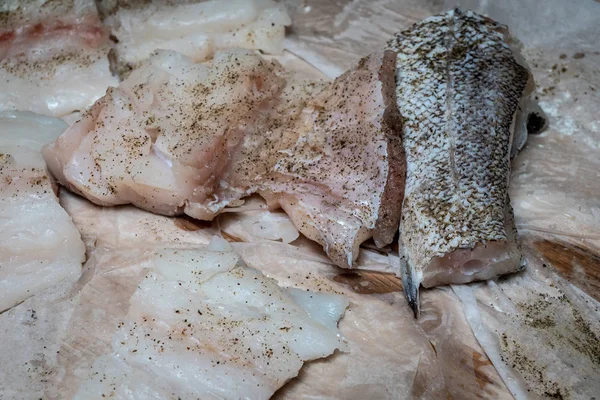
[[0, 0, 118, 117]]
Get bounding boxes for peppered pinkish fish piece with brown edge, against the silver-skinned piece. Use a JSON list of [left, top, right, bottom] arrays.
[[261, 51, 405, 268]]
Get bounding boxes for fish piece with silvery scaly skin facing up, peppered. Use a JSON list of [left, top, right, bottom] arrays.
[[388, 9, 530, 314]]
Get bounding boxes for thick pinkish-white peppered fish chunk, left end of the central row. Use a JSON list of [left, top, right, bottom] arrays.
[[44, 50, 285, 220]]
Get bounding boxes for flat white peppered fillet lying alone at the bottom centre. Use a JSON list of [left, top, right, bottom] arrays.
[[74, 238, 348, 400]]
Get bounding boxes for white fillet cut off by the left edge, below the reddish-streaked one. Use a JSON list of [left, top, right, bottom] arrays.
[[0, 111, 85, 312]]
